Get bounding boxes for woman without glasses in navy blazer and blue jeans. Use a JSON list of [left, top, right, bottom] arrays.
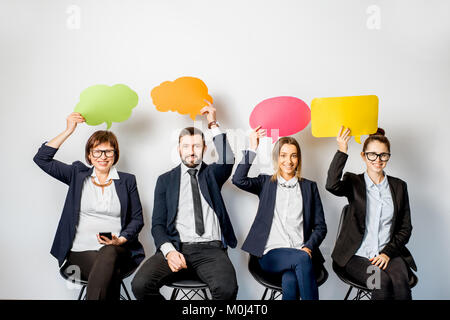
[[232, 127, 327, 300]]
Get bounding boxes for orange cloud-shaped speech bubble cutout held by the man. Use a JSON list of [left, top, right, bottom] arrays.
[[151, 77, 213, 120]]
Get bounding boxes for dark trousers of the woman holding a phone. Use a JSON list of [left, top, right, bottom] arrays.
[[67, 245, 134, 300]]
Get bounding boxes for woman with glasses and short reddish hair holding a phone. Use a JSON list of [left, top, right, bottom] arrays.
[[33, 112, 144, 300]]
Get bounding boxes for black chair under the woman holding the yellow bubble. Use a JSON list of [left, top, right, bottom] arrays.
[[333, 204, 419, 300]]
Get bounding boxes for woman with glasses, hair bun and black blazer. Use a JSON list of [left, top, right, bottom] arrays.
[[326, 127, 417, 300]]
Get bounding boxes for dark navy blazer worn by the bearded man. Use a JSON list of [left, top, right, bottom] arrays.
[[152, 133, 237, 250]]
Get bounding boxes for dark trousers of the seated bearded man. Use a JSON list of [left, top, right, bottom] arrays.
[[131, 244, 238, 300]]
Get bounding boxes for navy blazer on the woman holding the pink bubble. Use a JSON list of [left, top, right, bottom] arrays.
[[232, 150, 327, 271]]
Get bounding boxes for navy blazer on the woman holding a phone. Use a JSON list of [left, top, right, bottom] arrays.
[[33, 143, 145, 266]]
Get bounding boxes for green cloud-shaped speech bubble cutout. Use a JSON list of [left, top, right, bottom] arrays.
[[74, 84, 138, 129]]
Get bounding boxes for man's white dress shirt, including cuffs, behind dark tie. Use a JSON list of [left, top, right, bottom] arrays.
[[160, 127, 222, 257]]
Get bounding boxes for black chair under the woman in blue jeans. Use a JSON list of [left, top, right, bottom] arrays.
[[248, 255, 328, 300]]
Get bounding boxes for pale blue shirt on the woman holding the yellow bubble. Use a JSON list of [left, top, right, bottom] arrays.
[[355, 172, 394, 259]]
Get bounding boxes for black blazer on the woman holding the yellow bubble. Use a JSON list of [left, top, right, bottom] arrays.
[[326, 151, 417, 271]]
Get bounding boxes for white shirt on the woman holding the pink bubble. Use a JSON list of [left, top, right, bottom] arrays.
[[263, 176, 304, 254]]
